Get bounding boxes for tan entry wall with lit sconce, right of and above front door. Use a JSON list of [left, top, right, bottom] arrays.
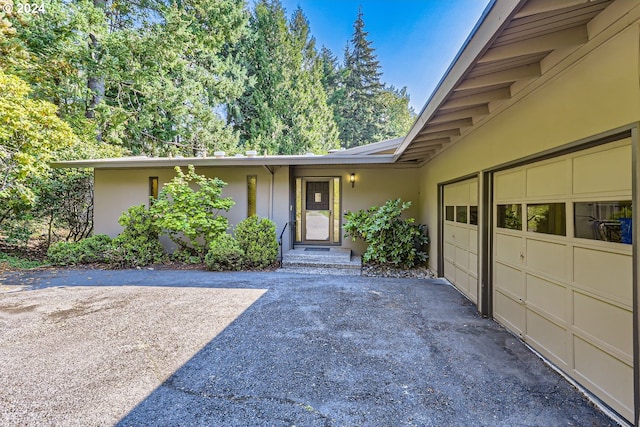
[[292, 165, 419, 254]]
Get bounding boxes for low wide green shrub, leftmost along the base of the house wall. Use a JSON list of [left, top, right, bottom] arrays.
[[47, 234, 111, 265]]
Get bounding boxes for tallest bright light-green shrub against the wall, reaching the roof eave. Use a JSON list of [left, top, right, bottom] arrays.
[[151, 165, 234, 261]]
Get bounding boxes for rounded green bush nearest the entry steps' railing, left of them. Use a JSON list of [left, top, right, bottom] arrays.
[[235, 215, 278, 268]]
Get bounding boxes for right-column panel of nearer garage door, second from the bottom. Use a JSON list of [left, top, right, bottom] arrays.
[[573, 292, 633, 359]]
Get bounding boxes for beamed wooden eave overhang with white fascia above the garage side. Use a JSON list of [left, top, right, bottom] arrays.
[[395, 0, 613, 164]]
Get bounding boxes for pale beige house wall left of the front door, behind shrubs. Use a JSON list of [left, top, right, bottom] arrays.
[[94, 166, 289, 248]]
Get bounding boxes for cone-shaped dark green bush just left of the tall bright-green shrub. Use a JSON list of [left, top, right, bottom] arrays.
[[109, 205, 167, 267]]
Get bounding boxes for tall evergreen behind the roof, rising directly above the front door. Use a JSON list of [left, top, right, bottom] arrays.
[[229, 0, 338, 154]]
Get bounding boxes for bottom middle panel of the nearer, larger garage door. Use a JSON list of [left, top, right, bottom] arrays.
[[527, 310, 567, 365]]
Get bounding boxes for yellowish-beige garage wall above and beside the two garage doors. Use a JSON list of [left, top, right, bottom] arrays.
[[419, 23, 640, 270]]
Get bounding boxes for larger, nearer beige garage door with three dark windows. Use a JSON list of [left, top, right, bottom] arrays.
[[493, 140, 633, 420]]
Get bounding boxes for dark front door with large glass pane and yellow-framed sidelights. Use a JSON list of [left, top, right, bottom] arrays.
[[296, 178, 340, 244]]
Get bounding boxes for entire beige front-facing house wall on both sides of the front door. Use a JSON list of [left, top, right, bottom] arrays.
[[94, 166, 419, 254]]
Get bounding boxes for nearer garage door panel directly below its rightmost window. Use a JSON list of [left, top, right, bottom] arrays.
[[573, 247, 633, 307]]
